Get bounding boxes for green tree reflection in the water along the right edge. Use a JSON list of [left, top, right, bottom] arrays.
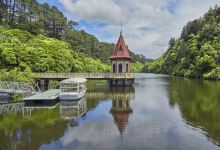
[[168, 78, 220, 144]]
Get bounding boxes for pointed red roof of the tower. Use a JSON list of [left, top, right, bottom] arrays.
[[109, 32, 132, 59]]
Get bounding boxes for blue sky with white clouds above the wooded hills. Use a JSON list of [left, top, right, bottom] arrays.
[[38, 0, 220, 59]]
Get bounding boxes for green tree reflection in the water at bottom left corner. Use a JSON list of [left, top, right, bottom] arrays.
[[0, 108, 66, 150]]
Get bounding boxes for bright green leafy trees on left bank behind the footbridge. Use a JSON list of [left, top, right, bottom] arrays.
[[0, 26, 111, 82]]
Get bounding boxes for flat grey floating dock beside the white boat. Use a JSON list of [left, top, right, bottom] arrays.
[[23, 89, 61, 101]]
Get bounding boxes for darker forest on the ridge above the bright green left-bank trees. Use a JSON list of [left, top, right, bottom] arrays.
[[0, 0, 146, 63]]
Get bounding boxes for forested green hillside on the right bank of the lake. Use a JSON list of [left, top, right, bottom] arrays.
[[144, 5, 220, 79]]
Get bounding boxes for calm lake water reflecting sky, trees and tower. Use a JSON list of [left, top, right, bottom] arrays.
[[0, 74, 220, 150]]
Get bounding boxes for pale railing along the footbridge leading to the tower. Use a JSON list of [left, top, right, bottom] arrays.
[[34, 72, 134, 79]]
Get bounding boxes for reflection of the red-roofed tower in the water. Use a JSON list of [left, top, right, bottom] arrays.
[[110, 87, 134, 135]]
